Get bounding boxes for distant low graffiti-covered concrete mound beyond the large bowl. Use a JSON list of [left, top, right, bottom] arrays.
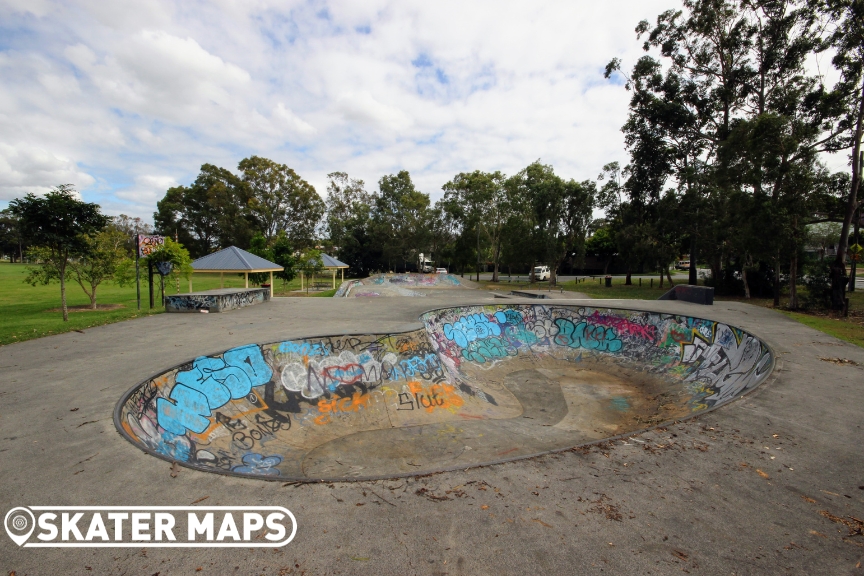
[[333, 273, 476, 298]]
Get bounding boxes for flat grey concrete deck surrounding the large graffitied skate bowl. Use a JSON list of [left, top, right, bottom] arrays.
[[0, 293, 864, 575]]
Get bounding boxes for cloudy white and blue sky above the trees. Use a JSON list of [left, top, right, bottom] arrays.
[[0, 0, 845, 222]]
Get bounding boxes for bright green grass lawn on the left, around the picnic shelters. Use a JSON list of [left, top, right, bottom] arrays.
[[0, 262, 352, 345]]
